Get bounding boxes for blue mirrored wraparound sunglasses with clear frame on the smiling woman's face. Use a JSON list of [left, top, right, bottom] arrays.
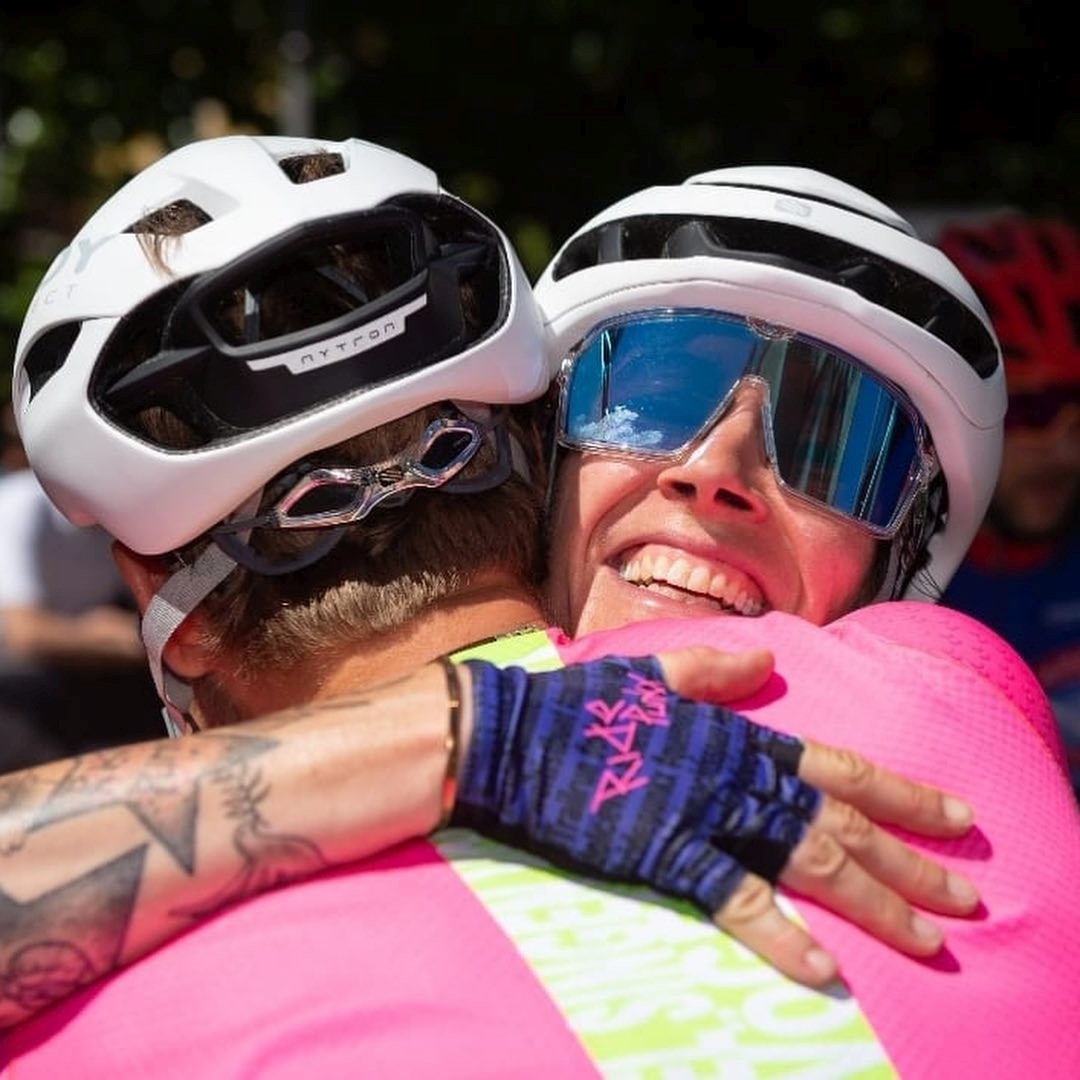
[[557, 310, 934, 537]]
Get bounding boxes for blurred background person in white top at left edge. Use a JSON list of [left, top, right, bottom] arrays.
[[0, 405, 160, 772]]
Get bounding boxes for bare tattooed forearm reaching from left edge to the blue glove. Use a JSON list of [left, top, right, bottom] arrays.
[[0, 667, 446, 1027]]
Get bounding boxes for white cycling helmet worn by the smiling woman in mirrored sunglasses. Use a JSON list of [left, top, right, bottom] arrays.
[[535, 166, 1005, 598]]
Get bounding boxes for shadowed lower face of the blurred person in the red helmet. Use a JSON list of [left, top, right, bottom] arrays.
[[991, 402, 1080, 540]]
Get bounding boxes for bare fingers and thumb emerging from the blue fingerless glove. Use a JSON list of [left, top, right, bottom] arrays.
[[639, 647, 978, 967]]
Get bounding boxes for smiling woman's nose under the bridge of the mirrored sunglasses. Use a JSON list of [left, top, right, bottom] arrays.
[[657, 383, 775, 521]]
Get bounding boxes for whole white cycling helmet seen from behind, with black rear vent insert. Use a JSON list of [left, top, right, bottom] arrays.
[[13, 136, 552, 554]]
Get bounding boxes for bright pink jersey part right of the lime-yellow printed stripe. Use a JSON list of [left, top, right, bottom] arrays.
[[561, 603, 1080, 1077]]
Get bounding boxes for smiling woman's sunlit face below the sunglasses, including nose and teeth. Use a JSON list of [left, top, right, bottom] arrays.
[[550, 382, 876, 634]]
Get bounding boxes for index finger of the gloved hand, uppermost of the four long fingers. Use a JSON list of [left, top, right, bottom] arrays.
[[799, 740, 974, 838]]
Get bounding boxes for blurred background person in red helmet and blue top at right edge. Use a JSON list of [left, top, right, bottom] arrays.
[[935, 211, 1080, 796]]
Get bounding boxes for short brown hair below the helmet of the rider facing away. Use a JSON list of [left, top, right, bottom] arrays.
[[184, 406, 544, 679]]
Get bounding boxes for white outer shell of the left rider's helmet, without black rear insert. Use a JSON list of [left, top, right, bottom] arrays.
[[13, 136, 553, 554]]
